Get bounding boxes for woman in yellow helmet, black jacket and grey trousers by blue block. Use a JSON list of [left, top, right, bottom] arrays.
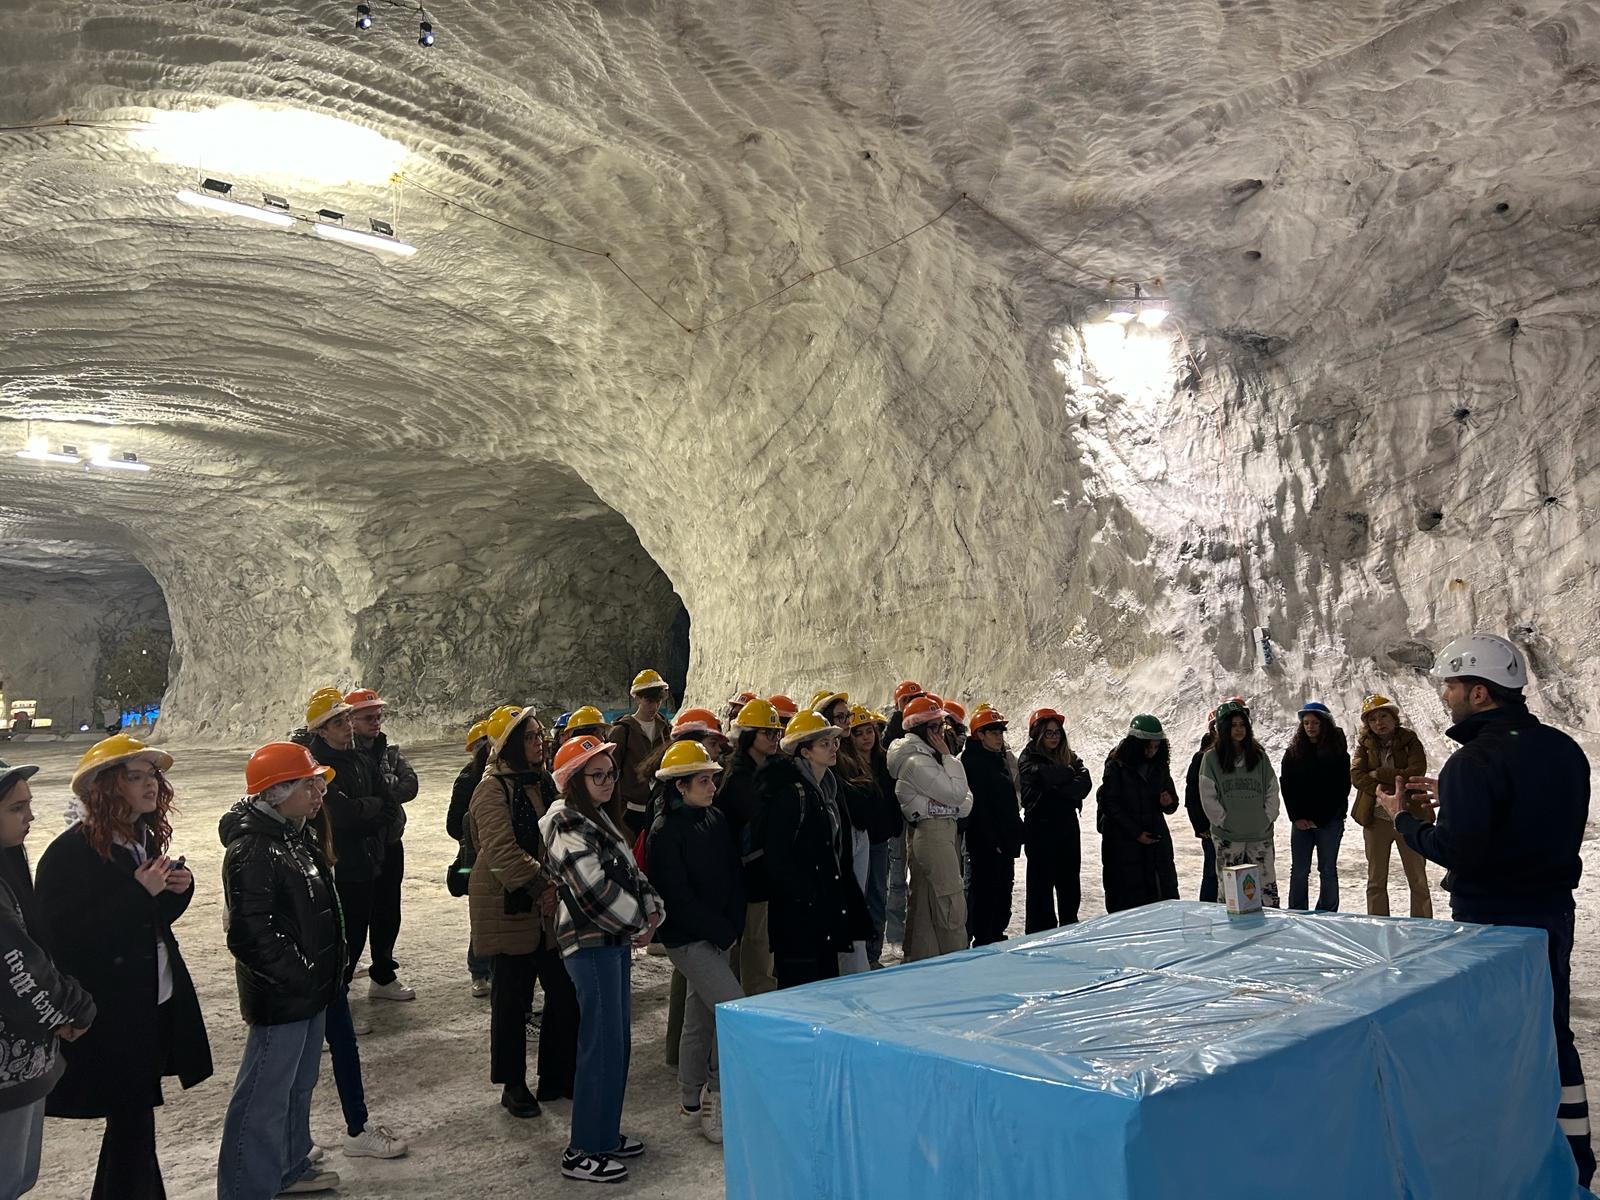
[[646, 741, 744, 1142]]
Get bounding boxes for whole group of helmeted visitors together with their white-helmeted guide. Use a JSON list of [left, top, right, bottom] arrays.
[[0, 635, 1594, 1200]]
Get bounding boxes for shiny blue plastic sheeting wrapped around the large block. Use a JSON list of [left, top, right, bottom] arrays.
[[717, 901, 1586, 1200]]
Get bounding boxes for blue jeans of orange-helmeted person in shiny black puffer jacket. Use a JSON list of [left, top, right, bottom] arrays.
[[216, 1013, 323, 1200]]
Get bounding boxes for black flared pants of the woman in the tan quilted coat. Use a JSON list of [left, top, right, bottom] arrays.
[[490, 949, 578, 1099]]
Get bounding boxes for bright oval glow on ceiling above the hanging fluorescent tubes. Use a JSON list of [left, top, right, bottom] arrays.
[[128, 102, 410, 194]]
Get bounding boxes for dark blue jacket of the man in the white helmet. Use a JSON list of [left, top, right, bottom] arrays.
[[1395, 709, 1589, 915]]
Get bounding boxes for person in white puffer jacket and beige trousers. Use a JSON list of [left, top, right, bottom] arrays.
[[889, 696, 973, 963]]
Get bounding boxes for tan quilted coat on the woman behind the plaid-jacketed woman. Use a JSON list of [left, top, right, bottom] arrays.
[[466, 758, 555, 957]]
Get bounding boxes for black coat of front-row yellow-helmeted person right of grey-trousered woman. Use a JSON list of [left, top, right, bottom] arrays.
[[757, 755, 872, 958]]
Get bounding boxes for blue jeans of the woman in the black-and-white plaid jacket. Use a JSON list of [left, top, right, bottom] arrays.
[[563, 946, 634, 1158]]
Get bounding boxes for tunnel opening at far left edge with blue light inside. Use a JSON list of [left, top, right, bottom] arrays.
[[0, 538, 173, 738]]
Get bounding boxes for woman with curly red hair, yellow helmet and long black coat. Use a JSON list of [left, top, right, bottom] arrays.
[[35, 734, 211, 1200]]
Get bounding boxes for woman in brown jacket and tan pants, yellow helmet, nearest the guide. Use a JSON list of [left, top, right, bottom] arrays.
[[1350, 696, 1434, 917]]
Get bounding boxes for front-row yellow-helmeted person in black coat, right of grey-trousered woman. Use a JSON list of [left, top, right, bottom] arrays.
[[755, 712, 869, 987]]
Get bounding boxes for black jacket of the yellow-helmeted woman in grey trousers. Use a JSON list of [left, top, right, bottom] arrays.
[[646, 805, 744, 950]]
